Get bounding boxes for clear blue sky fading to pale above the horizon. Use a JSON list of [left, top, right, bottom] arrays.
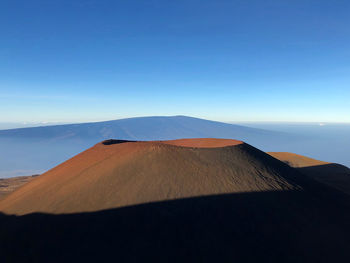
[[0, 0, 350, 122]]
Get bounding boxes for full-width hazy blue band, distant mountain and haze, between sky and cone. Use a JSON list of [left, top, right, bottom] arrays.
[[0, 116, 350, 177]]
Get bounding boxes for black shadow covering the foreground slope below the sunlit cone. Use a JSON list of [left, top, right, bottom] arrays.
[[0, 191, 350, 263]]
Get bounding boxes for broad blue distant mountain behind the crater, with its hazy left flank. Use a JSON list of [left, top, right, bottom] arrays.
[[0, 116, 293, 177]]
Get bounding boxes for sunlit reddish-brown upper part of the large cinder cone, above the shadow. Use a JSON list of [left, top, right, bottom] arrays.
[[0, 139, 302, 214]]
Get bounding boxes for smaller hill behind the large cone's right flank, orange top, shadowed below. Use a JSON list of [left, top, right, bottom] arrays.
[[269, 152, 350, 194]]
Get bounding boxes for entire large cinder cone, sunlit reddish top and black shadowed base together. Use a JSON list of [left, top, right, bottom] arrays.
[[0, 139, 350, 263]]
